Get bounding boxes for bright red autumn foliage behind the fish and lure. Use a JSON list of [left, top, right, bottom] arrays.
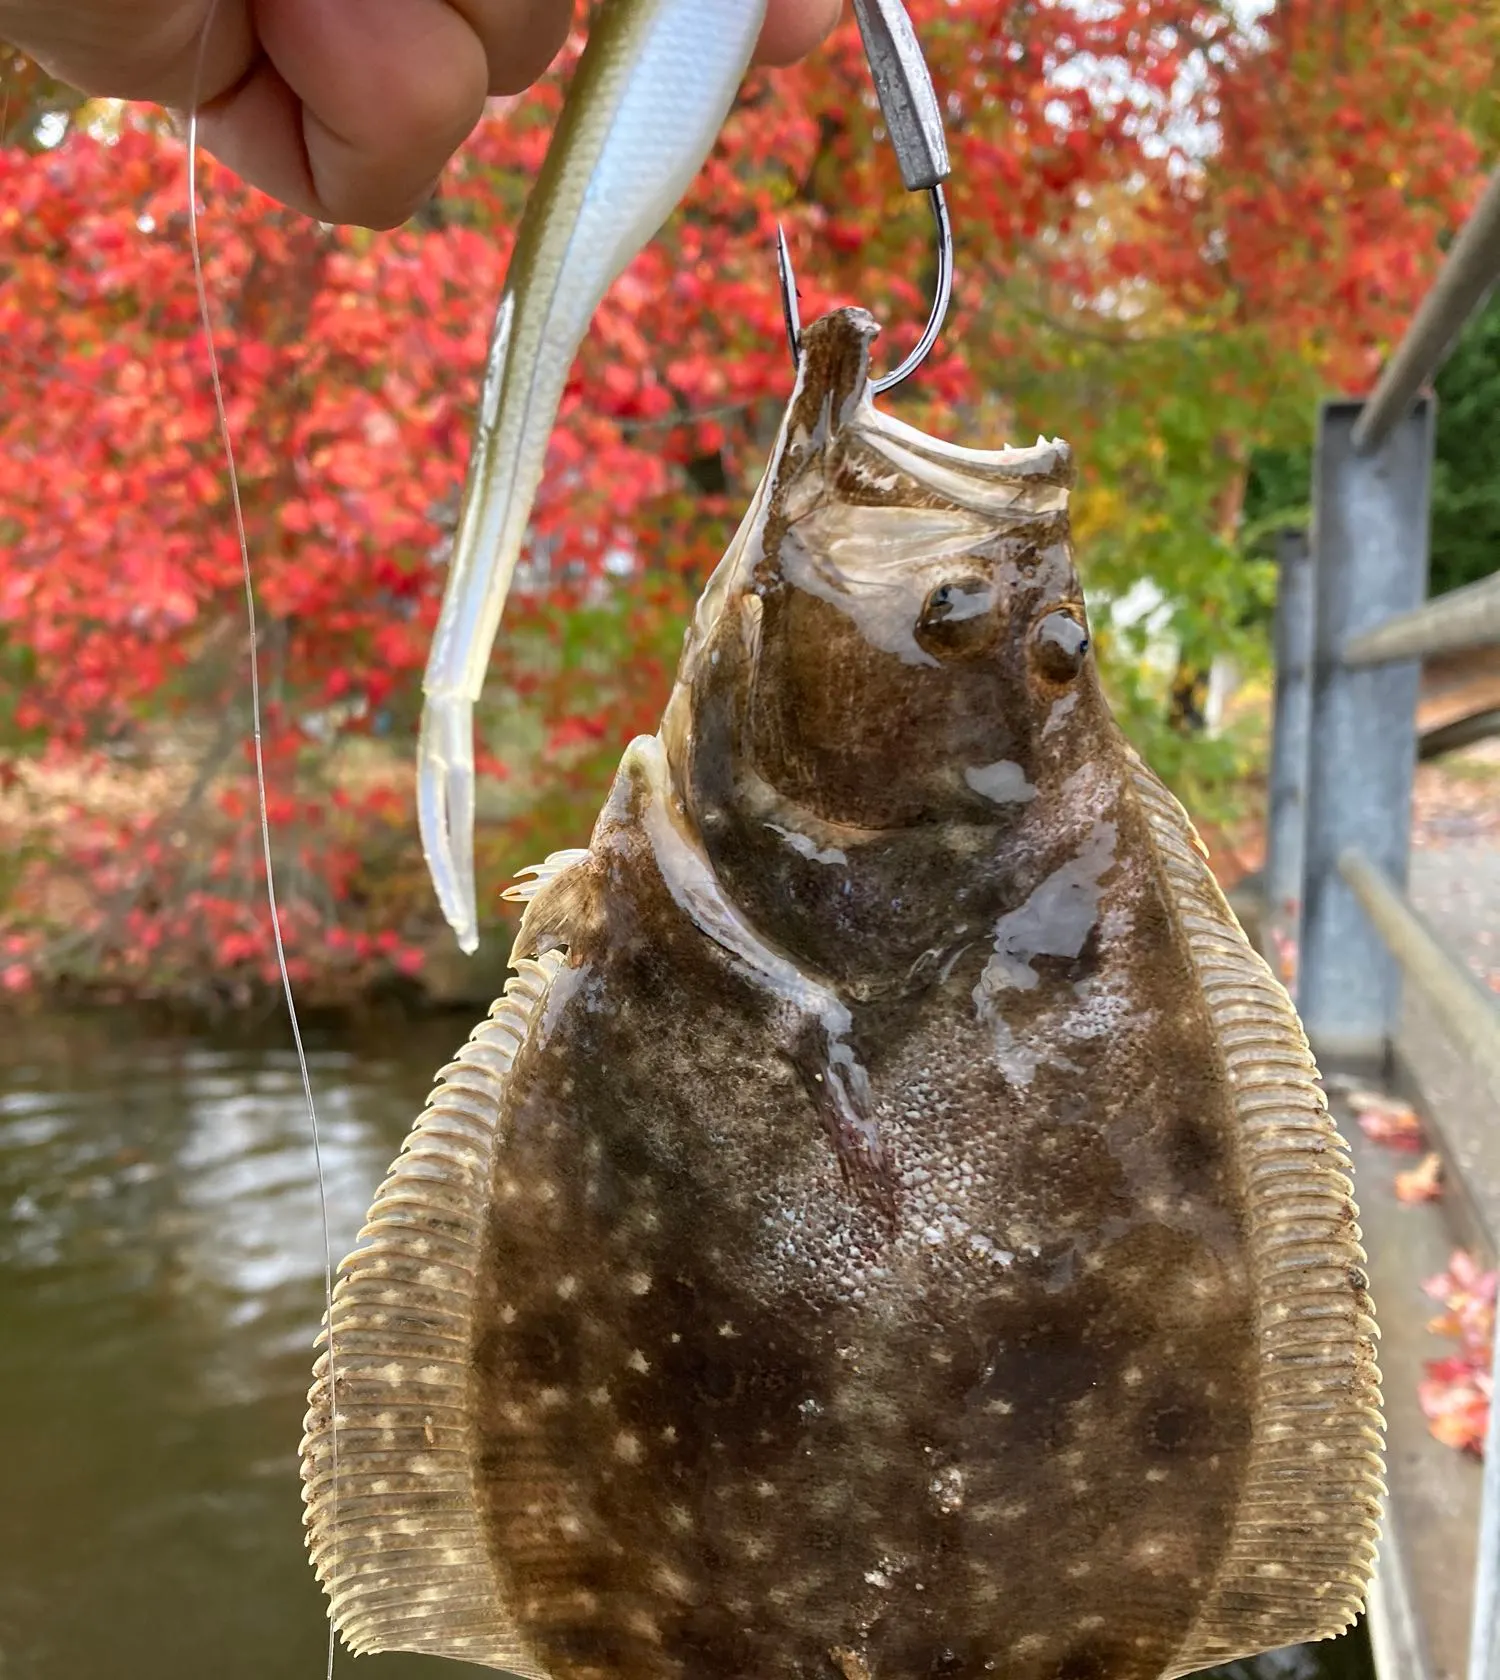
[[0, 0, 1493, 1000]]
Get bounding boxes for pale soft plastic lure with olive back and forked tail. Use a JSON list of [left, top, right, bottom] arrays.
[[417, 0, 766, 951]]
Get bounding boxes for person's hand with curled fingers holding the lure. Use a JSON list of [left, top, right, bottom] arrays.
[[0, 0, 840, 227]]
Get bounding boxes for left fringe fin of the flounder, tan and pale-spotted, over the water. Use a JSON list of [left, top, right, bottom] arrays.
[[302, 951, 564, 1680]]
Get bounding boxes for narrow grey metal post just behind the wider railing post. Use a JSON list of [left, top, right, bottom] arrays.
[[1265, 531, 1314, 984]]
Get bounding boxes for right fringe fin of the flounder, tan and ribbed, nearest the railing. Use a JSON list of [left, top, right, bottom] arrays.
[[1130, 754, 1384, 1675]]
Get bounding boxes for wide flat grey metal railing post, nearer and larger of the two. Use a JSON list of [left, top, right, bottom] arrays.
[[1298, 398, 1434, 1060]]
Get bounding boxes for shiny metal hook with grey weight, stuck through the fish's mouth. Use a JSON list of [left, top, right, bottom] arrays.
[[776, 0, 952, 395]]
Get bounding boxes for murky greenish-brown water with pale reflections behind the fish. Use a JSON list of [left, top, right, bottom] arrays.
[[0, 1011, 1371, 1680]]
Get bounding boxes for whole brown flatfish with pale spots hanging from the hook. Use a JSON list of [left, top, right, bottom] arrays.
[[304, 311, 1381, 1680]]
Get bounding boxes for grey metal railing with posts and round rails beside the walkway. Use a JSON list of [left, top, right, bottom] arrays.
[[1267, 171, 1500, 1680]]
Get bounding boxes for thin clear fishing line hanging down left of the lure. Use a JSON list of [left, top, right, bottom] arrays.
[[188, 19, 339, 1680]]
